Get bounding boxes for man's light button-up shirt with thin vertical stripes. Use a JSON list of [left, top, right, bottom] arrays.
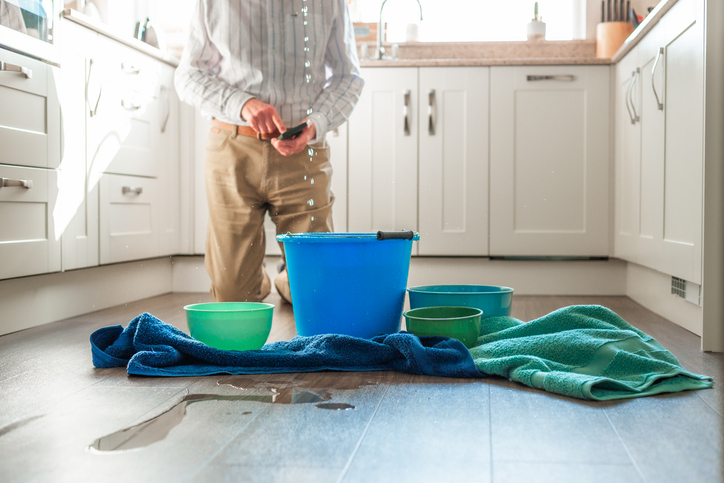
[[174, 0, 364, 139]]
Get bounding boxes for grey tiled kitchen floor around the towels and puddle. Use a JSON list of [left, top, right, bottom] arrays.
[[0, 294, 724, 483]]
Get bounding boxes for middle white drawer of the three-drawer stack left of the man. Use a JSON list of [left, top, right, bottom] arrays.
[[88, 84, 160, 177]]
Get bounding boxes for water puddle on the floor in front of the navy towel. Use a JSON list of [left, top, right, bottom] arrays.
[[88, 376, 377, 453]]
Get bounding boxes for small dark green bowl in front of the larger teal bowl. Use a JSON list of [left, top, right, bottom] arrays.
[[404, 306, 483, 349]]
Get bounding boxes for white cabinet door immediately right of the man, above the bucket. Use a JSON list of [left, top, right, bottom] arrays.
[[348, 67, 418, 246]]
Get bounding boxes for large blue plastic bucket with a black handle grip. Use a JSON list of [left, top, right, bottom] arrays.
[[277, 232, 420, 338]]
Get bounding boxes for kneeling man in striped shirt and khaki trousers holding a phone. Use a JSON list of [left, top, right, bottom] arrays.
[[175, 0, 363, 302]]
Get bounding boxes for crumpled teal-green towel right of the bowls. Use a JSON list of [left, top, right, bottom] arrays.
[[470, 305, 713, 400]]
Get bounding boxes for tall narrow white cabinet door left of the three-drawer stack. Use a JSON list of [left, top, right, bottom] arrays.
[[55, 21, 99, 270]]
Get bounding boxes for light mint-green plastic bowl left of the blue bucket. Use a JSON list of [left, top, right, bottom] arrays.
[[184, 302, 274, 351]]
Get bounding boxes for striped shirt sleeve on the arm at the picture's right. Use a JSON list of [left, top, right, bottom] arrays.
[[309, 0, 364, 142]]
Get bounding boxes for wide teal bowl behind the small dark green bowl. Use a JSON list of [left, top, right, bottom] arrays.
[[407, 285, 513, 318]]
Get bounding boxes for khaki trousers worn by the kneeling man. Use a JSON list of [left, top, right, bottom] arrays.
[[205, 127, 334, 302]]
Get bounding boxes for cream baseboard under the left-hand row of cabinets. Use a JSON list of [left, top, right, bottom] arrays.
[[0, 257, 172, 335]]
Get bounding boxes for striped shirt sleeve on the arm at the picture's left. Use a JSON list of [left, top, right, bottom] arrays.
[[174, 0, 254, 119]]
